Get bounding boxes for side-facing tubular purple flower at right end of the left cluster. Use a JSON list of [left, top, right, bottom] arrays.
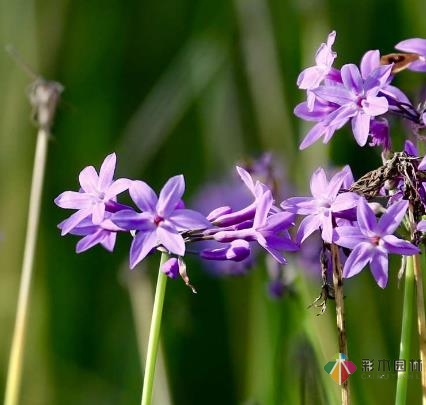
[[214, 190, 299, 264]]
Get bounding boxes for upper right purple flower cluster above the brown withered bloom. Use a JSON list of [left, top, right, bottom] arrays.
[[294, 31, 426, 151]]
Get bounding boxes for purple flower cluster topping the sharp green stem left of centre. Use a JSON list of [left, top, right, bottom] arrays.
[[55, 154, 298, 288]]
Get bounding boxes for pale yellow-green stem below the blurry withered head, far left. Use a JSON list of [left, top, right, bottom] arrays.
[[4, 129, 49, 405]]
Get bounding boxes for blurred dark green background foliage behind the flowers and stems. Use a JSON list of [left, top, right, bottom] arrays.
[[0, 0, 426, 405]]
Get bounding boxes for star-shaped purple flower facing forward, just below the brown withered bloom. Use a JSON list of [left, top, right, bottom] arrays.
[[335, 199, 419, 288]]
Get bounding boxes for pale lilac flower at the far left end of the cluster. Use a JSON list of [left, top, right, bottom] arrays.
[[55, 153, 131, 235]]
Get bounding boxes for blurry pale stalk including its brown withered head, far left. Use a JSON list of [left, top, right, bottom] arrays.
[[4, 78, 62, 405]]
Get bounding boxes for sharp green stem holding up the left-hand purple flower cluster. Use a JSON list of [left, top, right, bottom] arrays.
[[141, 253, 168, 405]]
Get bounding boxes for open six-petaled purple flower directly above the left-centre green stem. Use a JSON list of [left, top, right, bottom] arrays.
[[112, 175, 211, 269]]
